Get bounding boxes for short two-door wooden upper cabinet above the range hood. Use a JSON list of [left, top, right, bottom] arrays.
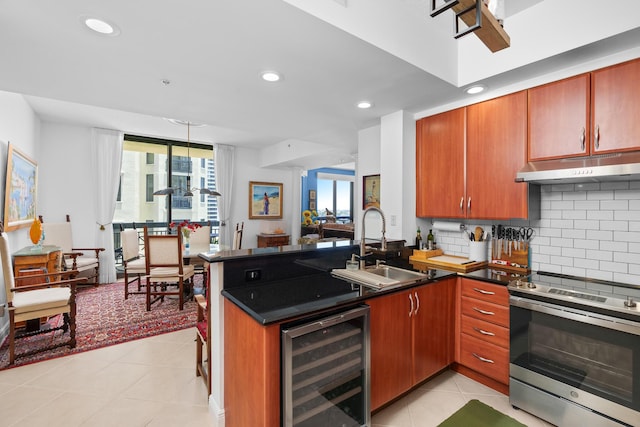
[[528, 60, 640, 161]]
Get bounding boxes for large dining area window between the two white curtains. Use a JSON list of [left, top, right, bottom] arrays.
[[114, 135, 218, 223]]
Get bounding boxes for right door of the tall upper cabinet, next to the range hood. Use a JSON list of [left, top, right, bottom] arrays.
[[464, 91, 528, 219]]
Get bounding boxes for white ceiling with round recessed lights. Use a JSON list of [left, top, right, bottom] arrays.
[[0, 0, 640, 168]]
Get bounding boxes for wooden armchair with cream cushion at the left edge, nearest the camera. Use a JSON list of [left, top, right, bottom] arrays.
[[0, 224, 87, 365]]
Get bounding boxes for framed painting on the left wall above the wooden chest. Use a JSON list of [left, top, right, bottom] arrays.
[[4, 144, 38, 231]]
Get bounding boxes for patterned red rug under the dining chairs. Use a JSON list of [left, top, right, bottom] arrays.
[[0, 275, 202, 370]]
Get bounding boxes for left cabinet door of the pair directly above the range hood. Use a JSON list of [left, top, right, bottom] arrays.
[[528, 74, 590, 161]]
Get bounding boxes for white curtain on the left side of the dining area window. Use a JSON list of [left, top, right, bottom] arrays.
[[91, 128, 124, 283]]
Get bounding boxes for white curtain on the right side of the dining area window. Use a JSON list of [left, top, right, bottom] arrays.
[[214, 144, 236, 248]]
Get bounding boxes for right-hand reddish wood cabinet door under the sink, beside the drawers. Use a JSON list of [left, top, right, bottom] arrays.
[[413, 279, 455, 384]]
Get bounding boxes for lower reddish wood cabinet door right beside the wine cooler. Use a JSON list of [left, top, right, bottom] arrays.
[[367, 291, 411, 410]]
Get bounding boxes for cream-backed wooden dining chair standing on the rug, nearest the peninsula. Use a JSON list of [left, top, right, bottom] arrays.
[[144, 227, 194, 311]]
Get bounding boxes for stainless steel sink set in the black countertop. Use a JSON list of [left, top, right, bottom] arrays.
[[331, 265, 429, 289]]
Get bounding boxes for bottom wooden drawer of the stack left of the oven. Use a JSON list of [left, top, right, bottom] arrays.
[[460, 334, 509, 384]]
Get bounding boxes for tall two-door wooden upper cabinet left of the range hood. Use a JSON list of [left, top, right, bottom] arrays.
[[416, 91, 535, 219]]
